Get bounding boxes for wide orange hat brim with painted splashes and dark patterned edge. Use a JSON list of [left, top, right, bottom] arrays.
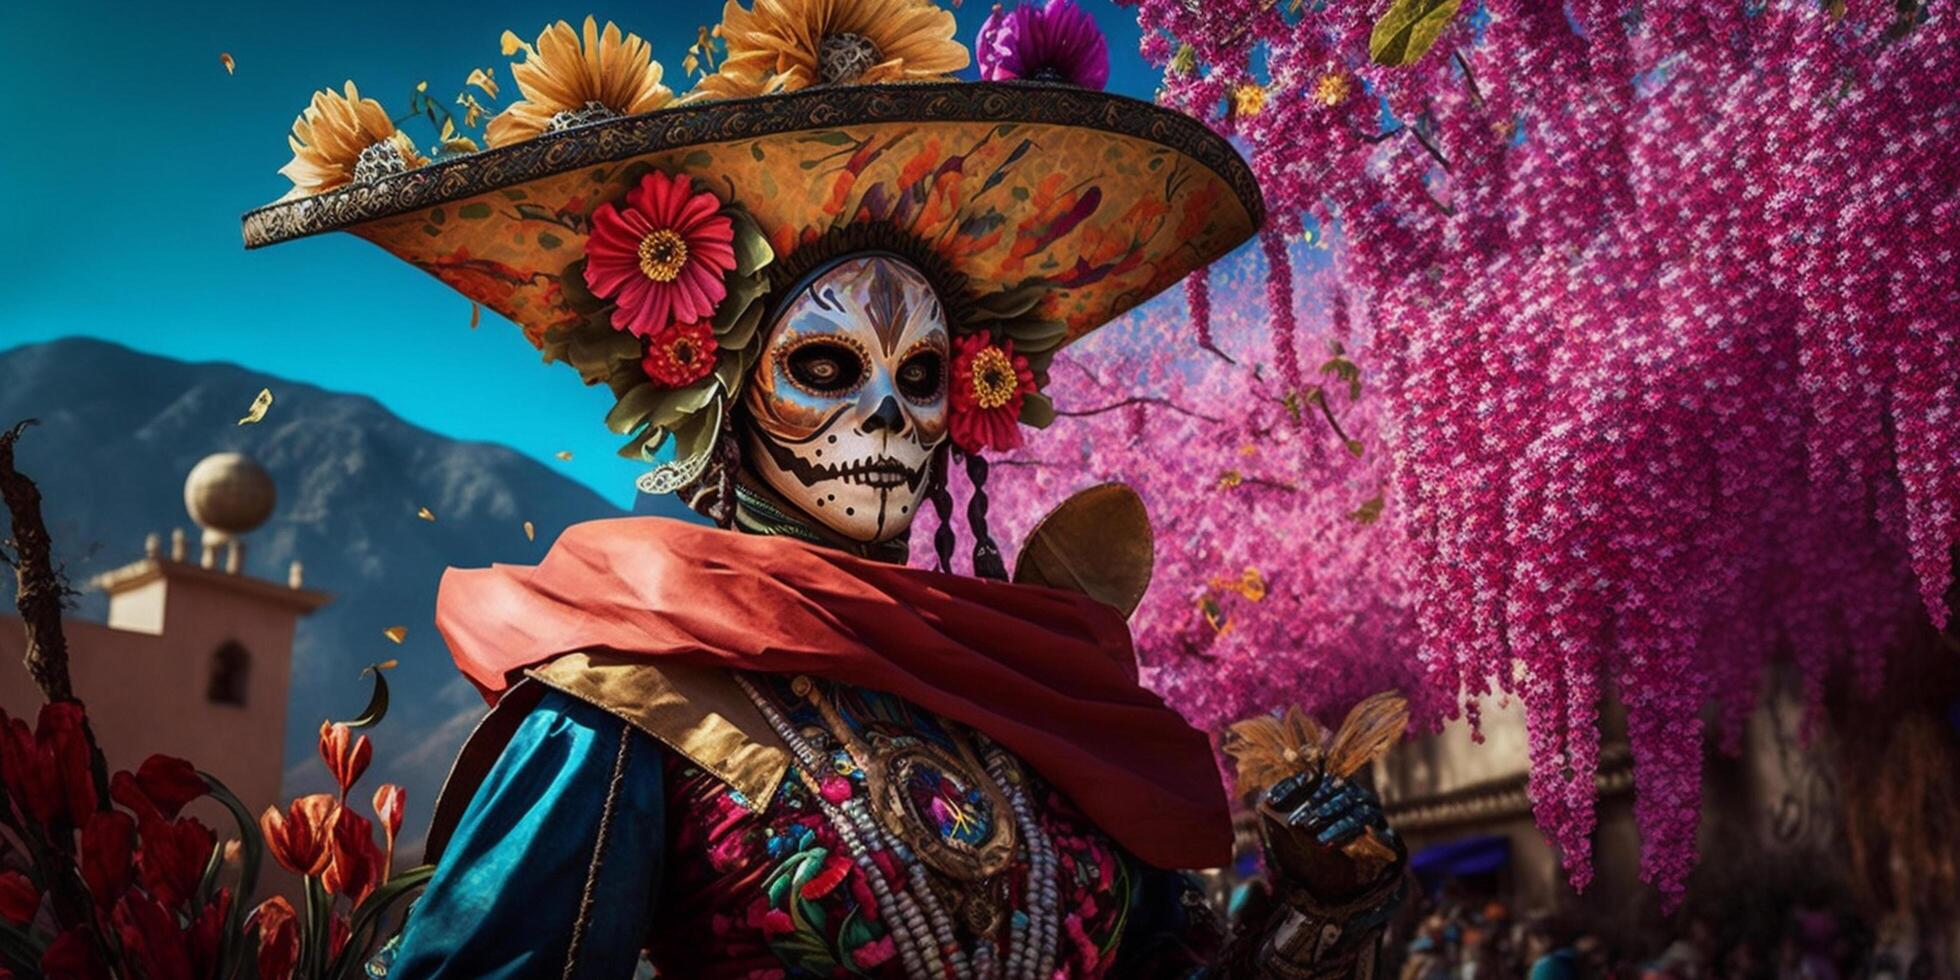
[[245, 82, 1264, 345]]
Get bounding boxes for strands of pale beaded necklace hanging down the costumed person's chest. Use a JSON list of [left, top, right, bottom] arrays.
[[735, 674, 1060, 980]]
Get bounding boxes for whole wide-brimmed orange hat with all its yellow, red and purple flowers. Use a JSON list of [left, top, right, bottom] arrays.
[[245, 0, 1262, 512]]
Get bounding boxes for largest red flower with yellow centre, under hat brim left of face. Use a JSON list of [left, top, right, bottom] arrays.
[[586, 171, 735, 337]]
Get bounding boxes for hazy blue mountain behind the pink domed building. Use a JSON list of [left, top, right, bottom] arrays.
[[0, 339, 697, 853]]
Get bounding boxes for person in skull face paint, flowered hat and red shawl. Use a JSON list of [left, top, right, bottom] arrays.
[[245, 0, 1401, 980]]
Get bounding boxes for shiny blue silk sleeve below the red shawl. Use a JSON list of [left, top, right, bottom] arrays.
[[388, 692, 666, 980]]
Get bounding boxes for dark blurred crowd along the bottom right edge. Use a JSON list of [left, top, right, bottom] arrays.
[[1386, 890, 1952, 980]]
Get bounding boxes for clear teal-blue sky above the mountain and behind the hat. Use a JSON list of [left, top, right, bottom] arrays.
[[0, 0, 1156, 506]]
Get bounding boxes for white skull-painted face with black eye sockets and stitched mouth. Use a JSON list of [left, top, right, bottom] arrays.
[[743, 255, 949, 543]]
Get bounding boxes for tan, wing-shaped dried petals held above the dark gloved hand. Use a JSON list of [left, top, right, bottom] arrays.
[[1223, 690, 1409, 874]]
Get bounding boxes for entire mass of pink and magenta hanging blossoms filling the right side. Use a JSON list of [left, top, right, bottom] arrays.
[[940, 0, 1960, 896]]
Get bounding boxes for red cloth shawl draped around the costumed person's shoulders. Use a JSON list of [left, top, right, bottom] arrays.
[[435, 517, 1231, 868]]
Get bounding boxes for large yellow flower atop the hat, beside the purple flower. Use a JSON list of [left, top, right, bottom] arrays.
[[692, 0, 970, 98]]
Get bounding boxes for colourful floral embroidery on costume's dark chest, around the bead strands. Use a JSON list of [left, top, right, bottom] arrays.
[[649, 684, 1131, 980]]
